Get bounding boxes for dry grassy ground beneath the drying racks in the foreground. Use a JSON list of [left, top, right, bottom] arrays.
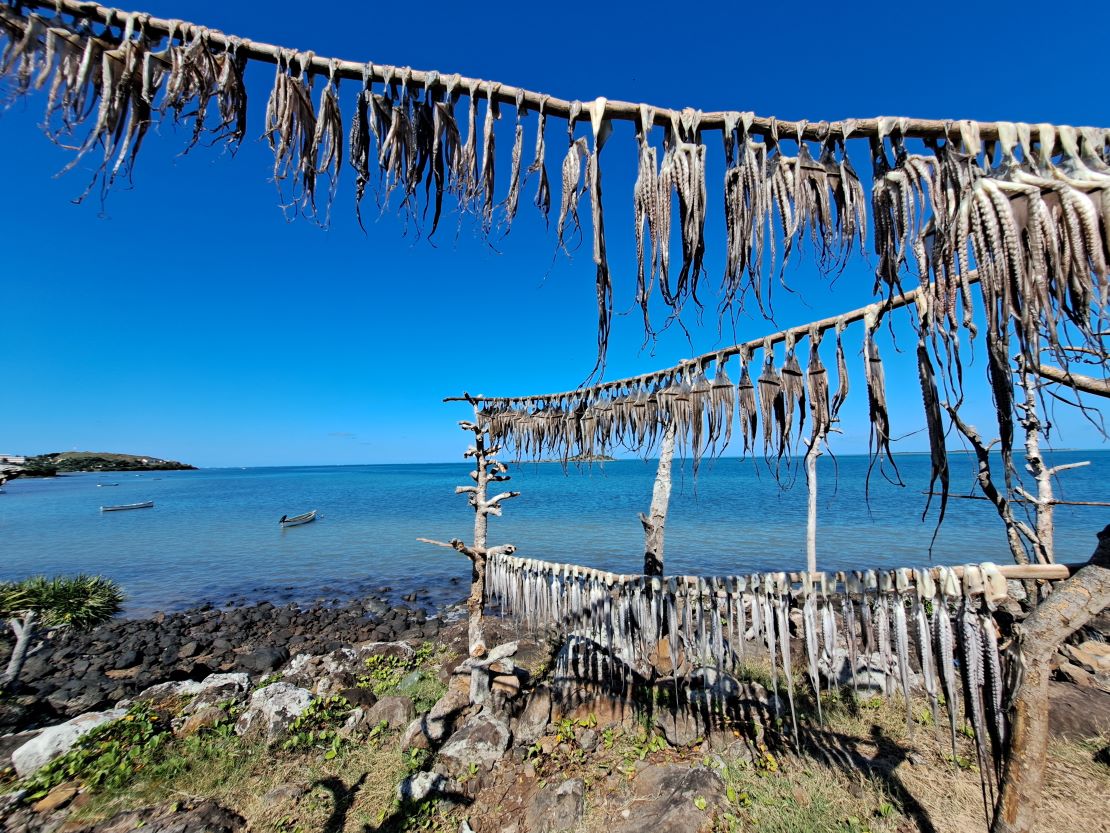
[[4, 652, 1110, 833]]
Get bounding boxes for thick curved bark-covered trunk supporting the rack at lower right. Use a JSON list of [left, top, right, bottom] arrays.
[[991, 525, 1110, 833]]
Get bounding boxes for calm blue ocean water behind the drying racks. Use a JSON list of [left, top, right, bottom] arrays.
[[0, 451, 1110, 615]]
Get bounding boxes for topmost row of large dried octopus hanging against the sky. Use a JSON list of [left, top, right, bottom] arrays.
[[0, 3, 1110, 367]]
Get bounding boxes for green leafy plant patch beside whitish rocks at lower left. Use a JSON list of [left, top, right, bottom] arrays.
[[23, 703, 171, 801]]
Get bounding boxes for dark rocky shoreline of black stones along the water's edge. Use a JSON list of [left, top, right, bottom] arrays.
[[0, 588, 450, 734]]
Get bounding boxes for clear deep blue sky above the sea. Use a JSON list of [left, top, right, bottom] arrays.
[[0, 0, 1110, 465]]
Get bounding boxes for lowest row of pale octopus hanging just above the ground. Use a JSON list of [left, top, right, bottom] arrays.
[[485, 554, 1007, 808]]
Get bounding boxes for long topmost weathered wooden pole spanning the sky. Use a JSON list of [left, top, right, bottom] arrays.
[[22, 0, 1101, 148]]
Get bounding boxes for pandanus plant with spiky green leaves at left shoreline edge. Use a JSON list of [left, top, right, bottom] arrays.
[[0, 574, 123, 692]]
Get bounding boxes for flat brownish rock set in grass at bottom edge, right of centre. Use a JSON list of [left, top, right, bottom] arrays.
[[609, 764, 726, 833]]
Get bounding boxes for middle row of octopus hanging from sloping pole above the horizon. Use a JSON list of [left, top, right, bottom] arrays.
[[481, 305, 941, 508]]
